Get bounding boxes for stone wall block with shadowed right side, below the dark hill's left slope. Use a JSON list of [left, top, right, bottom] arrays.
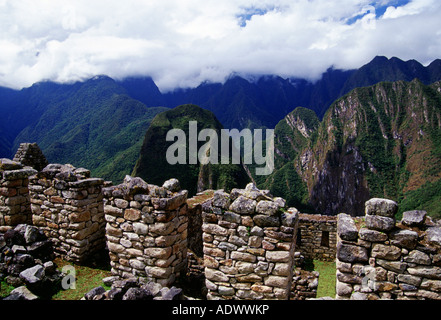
[[104, 176, 188, 286]]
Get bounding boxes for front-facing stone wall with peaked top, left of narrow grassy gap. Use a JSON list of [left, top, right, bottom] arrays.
[[202, 184, 298, 300]]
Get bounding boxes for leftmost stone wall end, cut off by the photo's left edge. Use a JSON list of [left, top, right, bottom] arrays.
[[0, 159, 37, 232]]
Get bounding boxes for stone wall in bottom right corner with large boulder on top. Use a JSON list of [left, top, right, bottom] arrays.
[[336, 199, 441, 300]]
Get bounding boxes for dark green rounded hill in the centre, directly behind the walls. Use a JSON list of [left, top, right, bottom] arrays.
[[132, 104, 249, 196]]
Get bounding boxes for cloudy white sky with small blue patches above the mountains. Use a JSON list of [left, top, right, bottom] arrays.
[[0, 0, 441, 92]]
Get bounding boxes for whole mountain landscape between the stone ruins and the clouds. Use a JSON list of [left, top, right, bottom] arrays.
[[0, 57, 441, 216]]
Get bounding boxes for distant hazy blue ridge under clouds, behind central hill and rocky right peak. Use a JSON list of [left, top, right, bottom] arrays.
[[154, 56, 441, 129]]
